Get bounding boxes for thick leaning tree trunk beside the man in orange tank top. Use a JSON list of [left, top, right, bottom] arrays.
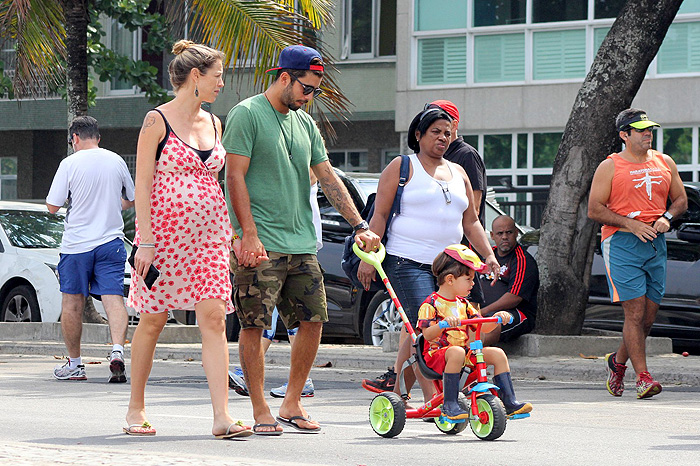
[[536, 0, 682, 335]]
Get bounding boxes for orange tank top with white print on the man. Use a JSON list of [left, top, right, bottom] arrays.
[[601, 150, 671, 239]]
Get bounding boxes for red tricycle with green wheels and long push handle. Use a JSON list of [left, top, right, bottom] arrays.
[[353, 245, 529, 440]]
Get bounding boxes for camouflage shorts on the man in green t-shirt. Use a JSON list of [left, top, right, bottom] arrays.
[[231, 251, 328, 330]]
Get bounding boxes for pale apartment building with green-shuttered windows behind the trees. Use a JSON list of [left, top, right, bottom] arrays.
[[0, 0, 700, 213]]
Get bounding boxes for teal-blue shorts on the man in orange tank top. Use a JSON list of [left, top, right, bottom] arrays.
[[601, 231, 666, 304]]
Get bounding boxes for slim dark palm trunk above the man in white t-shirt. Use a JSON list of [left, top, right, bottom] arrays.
[[63, 0, 90, 124]]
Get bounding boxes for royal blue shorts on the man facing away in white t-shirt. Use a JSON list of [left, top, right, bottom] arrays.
[[58, 238, 126, 297]]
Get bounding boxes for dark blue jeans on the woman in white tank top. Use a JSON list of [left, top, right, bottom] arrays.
[[382, 254, 437, 328]]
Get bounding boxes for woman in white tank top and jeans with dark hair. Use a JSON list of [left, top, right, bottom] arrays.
[[357, 108, 499, 400]]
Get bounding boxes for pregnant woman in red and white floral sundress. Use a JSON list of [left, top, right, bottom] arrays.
[[124, 40, 252, 438]]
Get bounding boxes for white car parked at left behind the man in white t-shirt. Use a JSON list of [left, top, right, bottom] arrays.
[[0, 201, 135, 322]]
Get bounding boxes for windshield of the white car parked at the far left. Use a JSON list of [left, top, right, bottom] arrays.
[[0, 210, 63, 248]]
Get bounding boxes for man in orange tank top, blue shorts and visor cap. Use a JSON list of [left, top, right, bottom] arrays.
[[588, 108, 688, 398]]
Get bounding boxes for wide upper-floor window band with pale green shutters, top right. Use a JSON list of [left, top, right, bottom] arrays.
[[412, 0, 700, 87]]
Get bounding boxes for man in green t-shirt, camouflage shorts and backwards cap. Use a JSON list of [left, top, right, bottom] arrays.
[[222, 45, 379, 435]]
